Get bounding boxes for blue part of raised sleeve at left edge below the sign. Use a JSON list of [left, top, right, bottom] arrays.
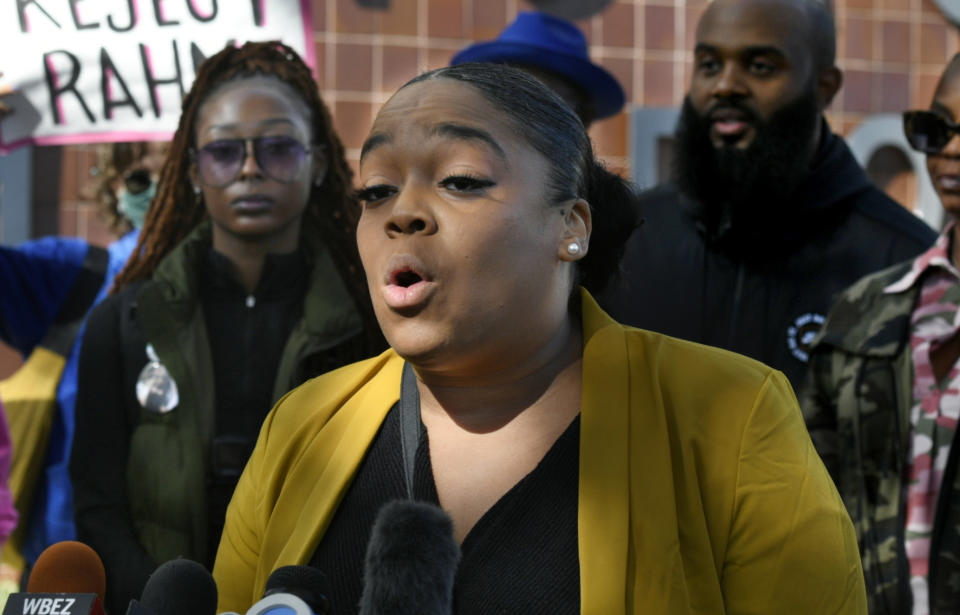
[[0, 237, 90, 356]]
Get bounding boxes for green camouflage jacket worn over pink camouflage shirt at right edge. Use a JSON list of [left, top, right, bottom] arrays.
[[800, 262, 960, 615]]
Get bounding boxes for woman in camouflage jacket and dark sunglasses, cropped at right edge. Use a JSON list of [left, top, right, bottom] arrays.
[[801, 55, 960, 615]]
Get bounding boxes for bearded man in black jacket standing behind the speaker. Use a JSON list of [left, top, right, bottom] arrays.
[[602, 0, 936, 389]]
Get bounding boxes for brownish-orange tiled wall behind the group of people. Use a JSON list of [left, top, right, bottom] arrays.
[[0, 0, 960, 376]]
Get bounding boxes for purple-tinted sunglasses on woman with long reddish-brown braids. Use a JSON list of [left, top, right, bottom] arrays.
[[194, 136, 322, 188]]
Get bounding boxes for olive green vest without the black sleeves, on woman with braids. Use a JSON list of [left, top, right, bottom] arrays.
[[127, 224, 365, 562]]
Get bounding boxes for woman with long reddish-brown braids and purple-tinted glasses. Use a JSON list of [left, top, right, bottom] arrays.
[[71, 42, 382, 613]]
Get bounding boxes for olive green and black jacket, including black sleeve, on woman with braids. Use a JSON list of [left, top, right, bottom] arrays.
[[71, 223, 382, 610]]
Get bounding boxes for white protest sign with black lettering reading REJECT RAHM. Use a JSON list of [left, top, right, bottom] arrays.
[[0, 0, 315, 151]]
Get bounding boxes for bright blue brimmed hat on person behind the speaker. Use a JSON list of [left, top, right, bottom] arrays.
[[450, 12, 626, 119]]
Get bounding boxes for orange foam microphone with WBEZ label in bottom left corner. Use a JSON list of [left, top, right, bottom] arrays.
[[3, 540, 107, 615]]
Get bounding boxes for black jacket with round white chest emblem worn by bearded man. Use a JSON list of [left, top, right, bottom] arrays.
[[600, 131, 936, 390]]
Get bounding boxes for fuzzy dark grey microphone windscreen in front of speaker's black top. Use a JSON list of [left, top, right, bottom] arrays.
[[360, 500, 460, 615]]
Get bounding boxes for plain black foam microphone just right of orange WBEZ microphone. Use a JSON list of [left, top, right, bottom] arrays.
[[127, 559, 217, 615]]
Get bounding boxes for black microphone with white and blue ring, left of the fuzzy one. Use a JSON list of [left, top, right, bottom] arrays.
[[220, 566, 330, 615]]
